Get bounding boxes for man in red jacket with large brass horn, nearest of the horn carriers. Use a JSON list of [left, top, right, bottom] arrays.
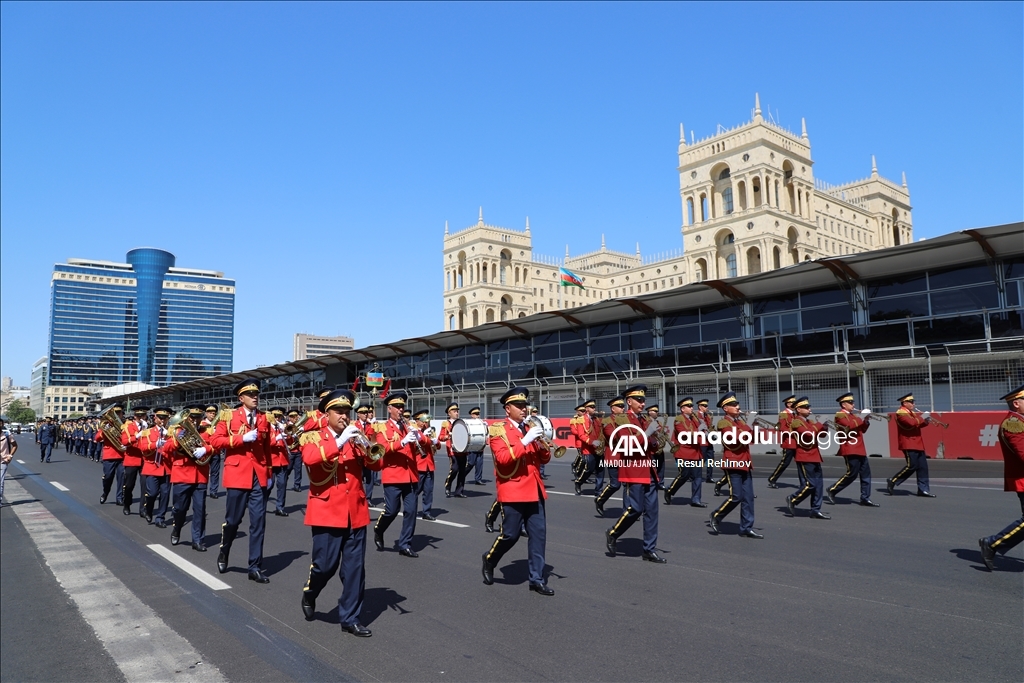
[[161, 405, 213, 553]]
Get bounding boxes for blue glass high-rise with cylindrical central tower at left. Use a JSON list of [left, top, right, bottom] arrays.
[[46, 248, 234, 387]]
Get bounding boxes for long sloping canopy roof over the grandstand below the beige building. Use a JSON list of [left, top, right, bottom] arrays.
[[103, 222, 1024, 400]]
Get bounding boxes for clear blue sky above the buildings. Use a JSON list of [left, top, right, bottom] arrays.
[[0, 2, 1024, 385]]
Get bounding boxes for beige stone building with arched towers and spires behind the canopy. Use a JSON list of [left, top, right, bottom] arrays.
[[442, 95, 913, 330]]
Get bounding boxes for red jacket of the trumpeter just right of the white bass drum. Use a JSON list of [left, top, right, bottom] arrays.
[[487, 420, 551, 503]]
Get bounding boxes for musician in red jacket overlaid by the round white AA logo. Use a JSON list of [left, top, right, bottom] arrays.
[[604, 384, 668, 564]]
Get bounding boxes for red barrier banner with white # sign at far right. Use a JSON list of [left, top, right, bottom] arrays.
[[889, 411, 1007, 460]]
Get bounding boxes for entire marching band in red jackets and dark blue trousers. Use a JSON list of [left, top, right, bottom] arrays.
[[29, 379, 1024, 637]]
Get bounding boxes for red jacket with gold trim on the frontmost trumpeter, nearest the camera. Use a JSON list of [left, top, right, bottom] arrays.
[[302, 427, 384, 528]]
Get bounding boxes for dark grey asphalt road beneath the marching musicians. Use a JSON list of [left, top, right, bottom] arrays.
[[0, 434, 1024, 681]]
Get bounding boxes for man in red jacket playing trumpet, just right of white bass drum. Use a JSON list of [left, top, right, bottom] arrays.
[[482, 387, 555, 596]]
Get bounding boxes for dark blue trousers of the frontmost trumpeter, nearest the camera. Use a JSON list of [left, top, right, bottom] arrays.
[[302, 526, 367, 626]]
